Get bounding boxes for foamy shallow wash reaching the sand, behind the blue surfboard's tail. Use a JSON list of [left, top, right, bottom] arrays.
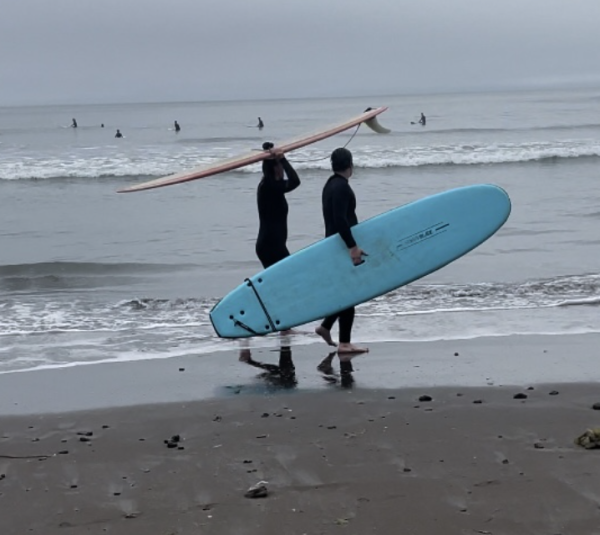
[[0, 272, 600, 373]]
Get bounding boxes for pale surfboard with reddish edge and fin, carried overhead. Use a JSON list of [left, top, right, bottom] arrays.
[[117, 106, 389, 193]]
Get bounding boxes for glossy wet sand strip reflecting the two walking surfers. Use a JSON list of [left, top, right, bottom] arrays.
[[0, 334, 600, 416]]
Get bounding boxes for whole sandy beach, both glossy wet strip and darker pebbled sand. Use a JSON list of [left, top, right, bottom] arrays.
[[0, 335, 600, 535]]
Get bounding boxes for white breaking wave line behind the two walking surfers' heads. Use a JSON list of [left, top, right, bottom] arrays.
[[0, 139, 600, 180]]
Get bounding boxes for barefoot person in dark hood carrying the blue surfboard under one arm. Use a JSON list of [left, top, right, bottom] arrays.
[[315, 148, 369, 354]]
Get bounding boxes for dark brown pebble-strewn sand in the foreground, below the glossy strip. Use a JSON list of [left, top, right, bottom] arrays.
[[0, 338, 600, 535]]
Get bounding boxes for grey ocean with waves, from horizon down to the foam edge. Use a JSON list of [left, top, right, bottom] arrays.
[[0, 89, 600, 373]]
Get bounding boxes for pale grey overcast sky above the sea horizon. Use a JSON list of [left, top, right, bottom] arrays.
[[0, 0, 600, 105]]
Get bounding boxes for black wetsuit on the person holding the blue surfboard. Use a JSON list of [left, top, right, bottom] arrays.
[[321, 174, 358, 344]]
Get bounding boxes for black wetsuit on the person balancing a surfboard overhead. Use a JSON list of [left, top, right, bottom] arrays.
[[256, 158, 300, 268]]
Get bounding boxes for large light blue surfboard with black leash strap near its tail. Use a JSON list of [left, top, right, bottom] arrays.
[[210, 184, 511, 338]]
